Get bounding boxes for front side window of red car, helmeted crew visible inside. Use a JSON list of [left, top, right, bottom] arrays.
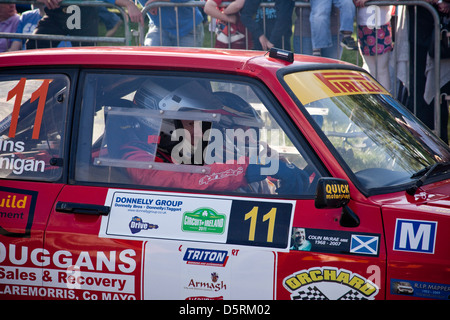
[[76, 73, 320, 195]]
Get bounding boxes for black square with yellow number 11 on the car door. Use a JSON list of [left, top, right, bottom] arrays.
[[227, 200, 293, 249]]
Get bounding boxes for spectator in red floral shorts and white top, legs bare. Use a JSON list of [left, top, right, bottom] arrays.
[[353, 0, 393, 91]]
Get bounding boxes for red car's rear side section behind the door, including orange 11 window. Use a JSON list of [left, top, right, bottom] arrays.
[[0, 70, 74, 299]]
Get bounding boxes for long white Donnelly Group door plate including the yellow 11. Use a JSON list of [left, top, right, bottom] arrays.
[[99, 189, 295, 251]]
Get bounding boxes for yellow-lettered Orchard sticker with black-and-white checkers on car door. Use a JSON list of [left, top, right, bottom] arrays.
[[283, 267, 379, 300]]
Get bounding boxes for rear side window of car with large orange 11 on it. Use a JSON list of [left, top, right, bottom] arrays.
[[0, 74, 69, 181]]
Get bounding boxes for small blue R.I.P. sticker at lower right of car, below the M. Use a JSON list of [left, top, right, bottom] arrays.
[[391, 279, 450, 300]]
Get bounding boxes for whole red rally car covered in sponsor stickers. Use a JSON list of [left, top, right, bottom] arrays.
[[0, 47, 450, 300]]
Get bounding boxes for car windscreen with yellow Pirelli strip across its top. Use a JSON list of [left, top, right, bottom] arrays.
[[287, 71, 450, 191]]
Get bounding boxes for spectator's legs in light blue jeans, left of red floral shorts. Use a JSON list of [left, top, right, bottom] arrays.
[[309, 0, 358, 56]]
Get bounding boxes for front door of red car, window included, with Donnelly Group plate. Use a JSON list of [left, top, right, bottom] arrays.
[[45, 70, 385, 300]]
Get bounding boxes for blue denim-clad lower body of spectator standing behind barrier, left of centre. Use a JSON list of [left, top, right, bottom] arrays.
[[139, 0, 204, 47]]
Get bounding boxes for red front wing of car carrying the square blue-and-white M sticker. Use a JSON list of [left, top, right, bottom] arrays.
[[383, 192, 450, 300]]
